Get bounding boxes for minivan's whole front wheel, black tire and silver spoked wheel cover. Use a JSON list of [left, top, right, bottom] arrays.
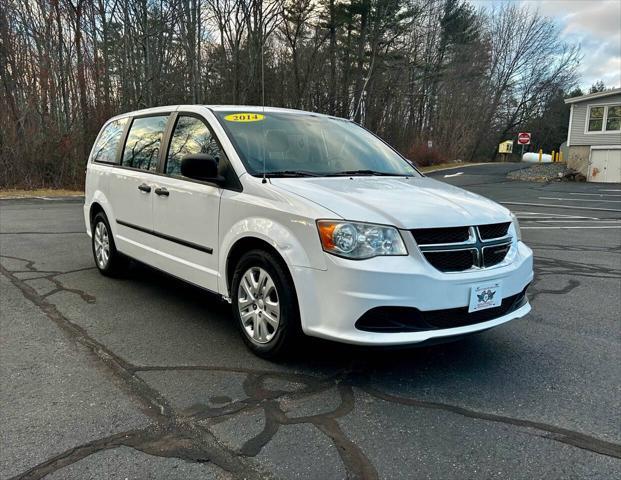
[[231, 250, 302, 359]]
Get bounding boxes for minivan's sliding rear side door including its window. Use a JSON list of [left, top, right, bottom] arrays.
[[109, 114, 169, 263]]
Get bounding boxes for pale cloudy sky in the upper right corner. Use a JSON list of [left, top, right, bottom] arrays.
[[471, 0, 621, 90]]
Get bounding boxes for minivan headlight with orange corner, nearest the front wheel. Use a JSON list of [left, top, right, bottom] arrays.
[[317, 220, 408, 260]]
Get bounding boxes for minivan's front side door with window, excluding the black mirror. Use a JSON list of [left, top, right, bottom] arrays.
[[153, 113, 224, 291]]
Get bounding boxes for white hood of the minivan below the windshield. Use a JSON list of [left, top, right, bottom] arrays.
[[271, 177, 510, 229]]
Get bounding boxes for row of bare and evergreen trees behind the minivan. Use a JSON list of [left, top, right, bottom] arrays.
[[0, 0, 580, 187]]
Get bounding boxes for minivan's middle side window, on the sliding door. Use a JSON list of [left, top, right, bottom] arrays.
[[121, 115, 168, 172]]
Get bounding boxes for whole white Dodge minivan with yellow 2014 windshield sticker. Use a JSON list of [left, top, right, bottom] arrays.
[[84, 105, 533, 357]]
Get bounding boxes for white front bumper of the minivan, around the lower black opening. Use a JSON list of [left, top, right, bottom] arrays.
[[292, 242, 533, 345]]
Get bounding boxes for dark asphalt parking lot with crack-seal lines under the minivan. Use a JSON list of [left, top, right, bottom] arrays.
[[0, 164, 621, 480]]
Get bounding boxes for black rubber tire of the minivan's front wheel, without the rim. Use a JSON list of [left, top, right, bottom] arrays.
[[231, 250, 303, 359]]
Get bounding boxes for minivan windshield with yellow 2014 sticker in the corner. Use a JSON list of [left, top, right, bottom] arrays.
[[214, 111, 419, 176]]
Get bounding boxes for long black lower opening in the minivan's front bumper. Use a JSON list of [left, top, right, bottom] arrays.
[[355, 285, 528, 333]]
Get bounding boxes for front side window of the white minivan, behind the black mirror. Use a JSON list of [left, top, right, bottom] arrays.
[[166, 115, 224, 176]]
